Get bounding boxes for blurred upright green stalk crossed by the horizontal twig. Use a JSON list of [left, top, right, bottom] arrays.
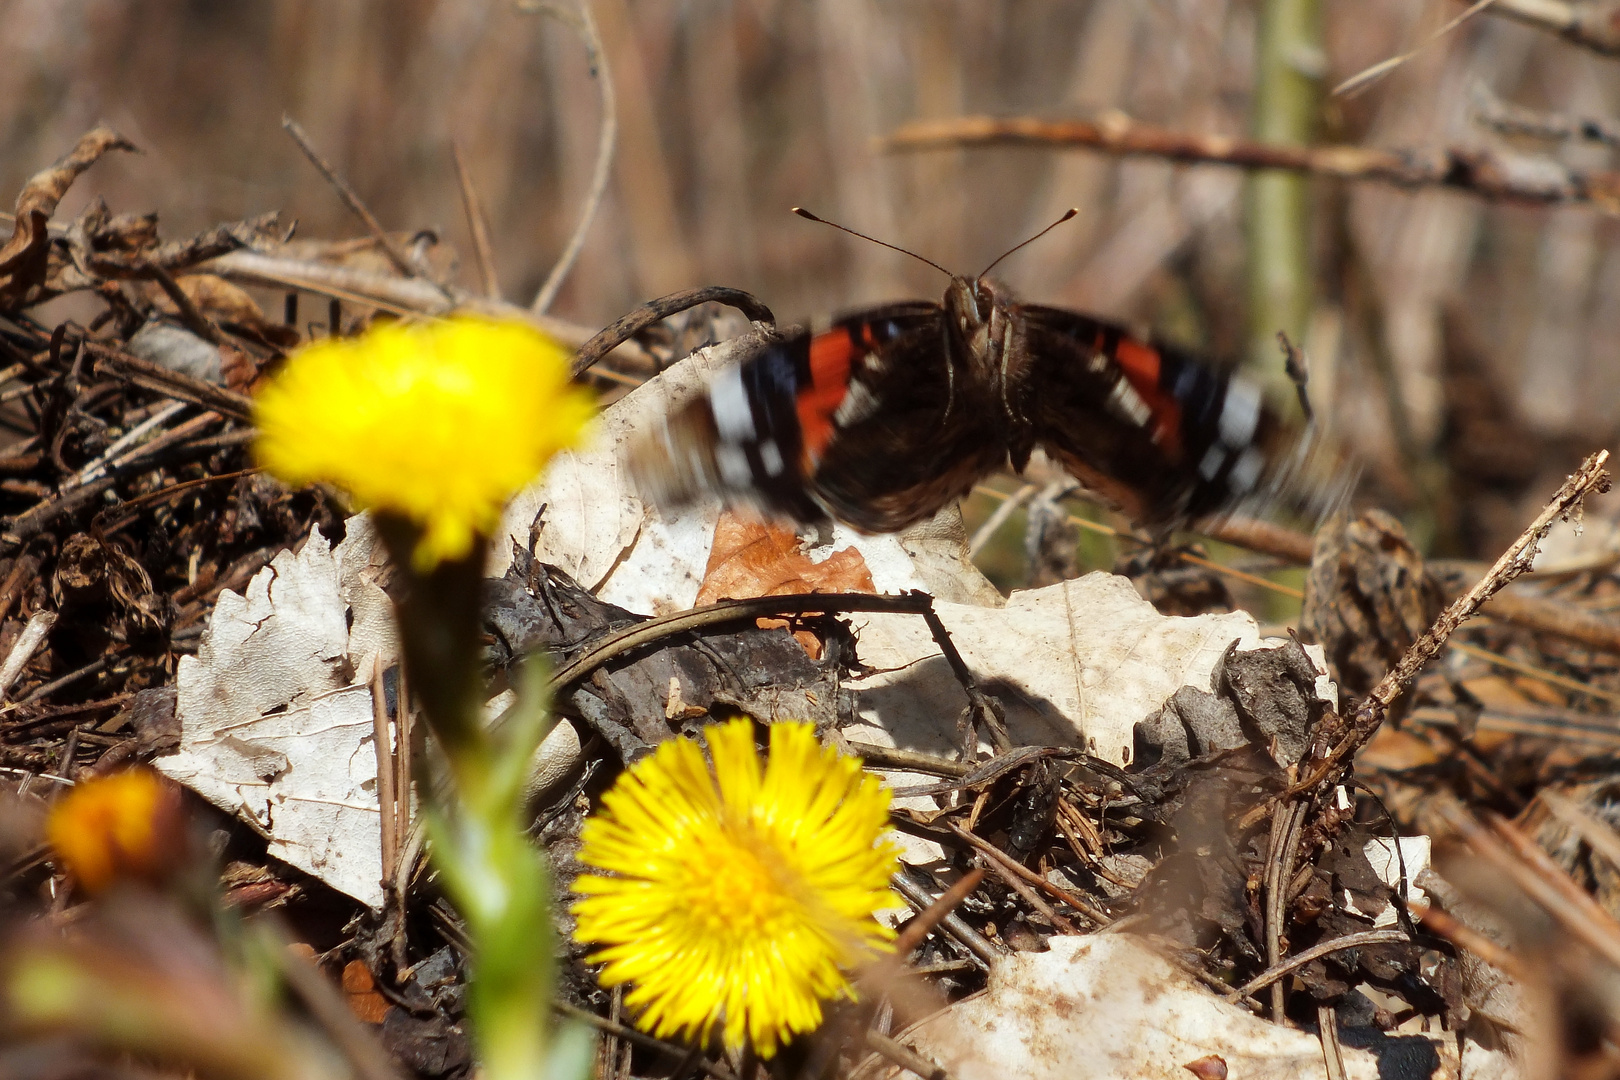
[[1246, 0, 1324, 395]]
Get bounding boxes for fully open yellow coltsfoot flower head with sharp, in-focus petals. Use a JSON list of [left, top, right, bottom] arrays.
[[572, 721, 897, 1057]]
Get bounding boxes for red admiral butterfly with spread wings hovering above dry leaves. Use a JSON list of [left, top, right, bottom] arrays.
[[629, 207, 1341, 533]]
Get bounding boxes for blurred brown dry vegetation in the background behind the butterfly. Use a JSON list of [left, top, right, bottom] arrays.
[[0, 0, 1620, 573]]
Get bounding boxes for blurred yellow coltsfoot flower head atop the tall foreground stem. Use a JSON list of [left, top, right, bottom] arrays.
[[254, 317, 593, 570]]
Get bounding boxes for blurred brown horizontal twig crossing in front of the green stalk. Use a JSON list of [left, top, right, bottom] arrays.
[[878, 112, 1620, 210]]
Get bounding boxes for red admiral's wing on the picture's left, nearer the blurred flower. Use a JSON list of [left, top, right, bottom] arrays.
[[630, 301, 1006, 533]]
